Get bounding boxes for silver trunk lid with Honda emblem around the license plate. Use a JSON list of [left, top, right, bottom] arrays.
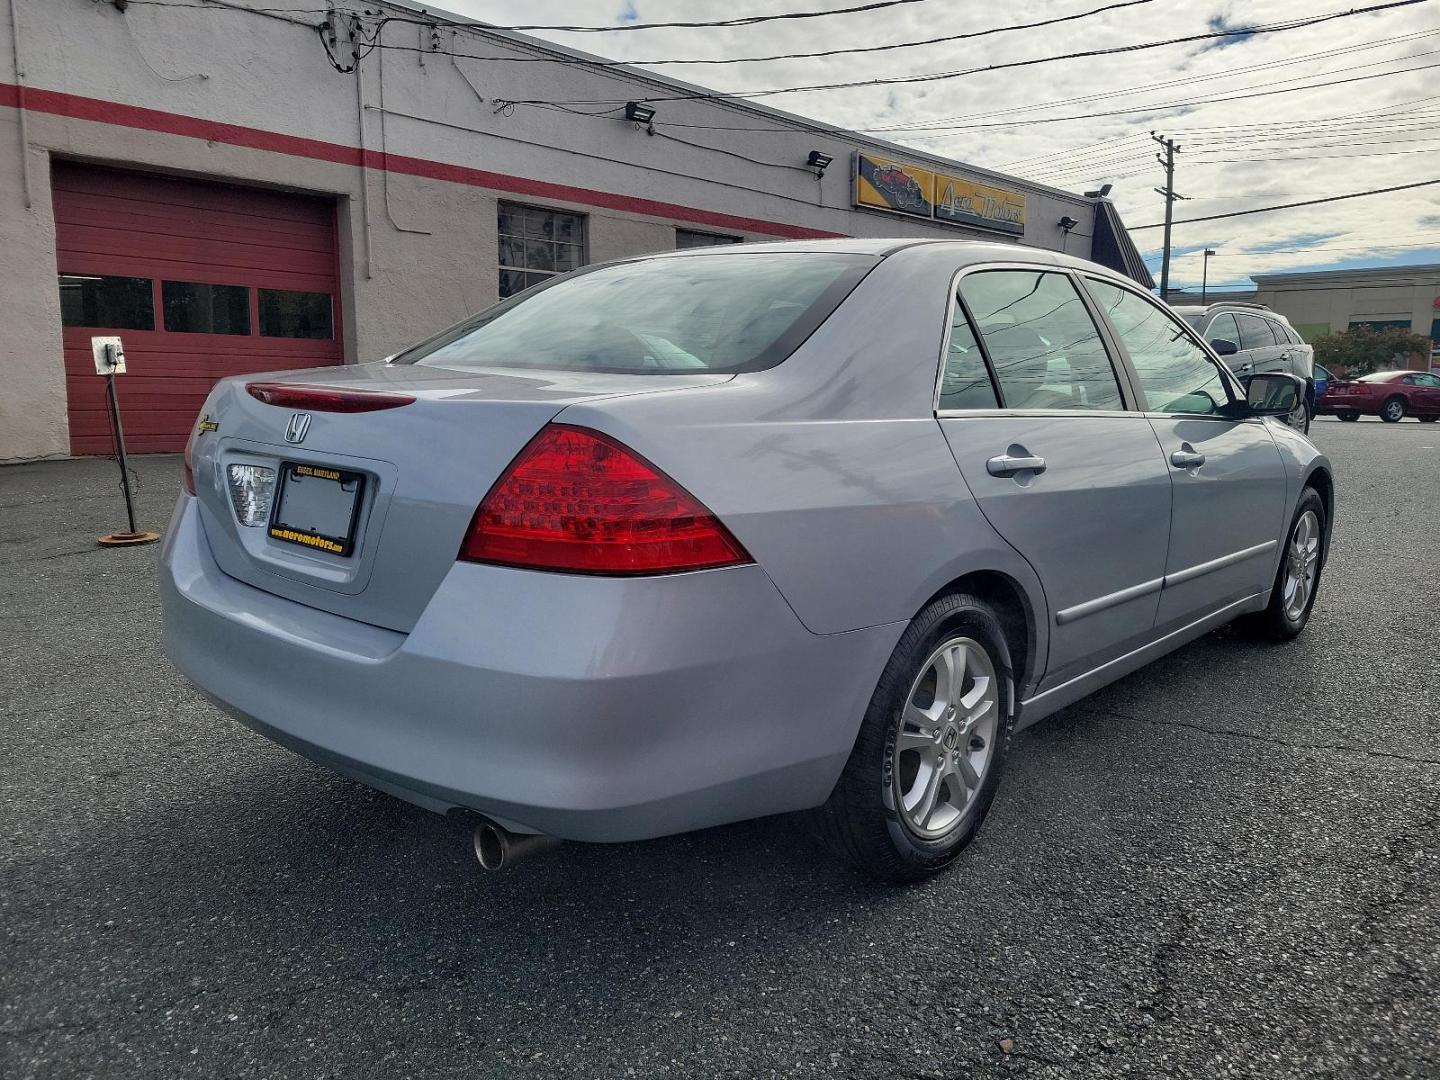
[[193, 364, 733, 632]]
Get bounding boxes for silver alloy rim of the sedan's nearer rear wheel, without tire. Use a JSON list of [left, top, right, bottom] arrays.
[[893, 636, 999, 840]]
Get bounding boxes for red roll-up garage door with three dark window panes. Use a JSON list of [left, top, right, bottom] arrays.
[[53, 161, 343, 454]]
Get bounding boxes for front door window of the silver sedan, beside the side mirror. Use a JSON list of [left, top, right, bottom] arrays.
[[1087, 278, 1230, 415]]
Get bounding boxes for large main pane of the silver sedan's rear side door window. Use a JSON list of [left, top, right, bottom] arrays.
[[960, 269, 1125, 409]]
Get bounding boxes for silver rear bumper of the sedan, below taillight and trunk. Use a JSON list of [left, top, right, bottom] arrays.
[[161, 495, 903, 841]]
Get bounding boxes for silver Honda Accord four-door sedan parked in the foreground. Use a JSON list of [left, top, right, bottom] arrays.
[[161, 240, 1335, 881]]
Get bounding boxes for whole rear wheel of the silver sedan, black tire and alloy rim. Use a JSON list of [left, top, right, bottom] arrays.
[[812, 593, 1014, 884]]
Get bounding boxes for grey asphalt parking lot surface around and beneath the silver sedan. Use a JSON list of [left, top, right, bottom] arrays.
[[0, 420, 1440, 1079]]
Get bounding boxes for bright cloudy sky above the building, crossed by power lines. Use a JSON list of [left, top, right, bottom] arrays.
[[441, 0, 1440, 287]]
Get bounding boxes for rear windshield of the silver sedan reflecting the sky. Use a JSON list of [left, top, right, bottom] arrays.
[[395, 252, 877, 374]]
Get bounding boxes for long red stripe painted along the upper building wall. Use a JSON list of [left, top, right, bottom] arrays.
[[0, 82, 844, 240]]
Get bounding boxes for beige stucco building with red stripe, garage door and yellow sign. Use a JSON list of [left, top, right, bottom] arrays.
[[0, 0, 1149, 461]]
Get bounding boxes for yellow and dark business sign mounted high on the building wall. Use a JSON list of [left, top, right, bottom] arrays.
[[855, 151, 1025, 236]]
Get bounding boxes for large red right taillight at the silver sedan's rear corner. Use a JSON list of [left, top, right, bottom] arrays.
[[459, 423, 752, 575]]
